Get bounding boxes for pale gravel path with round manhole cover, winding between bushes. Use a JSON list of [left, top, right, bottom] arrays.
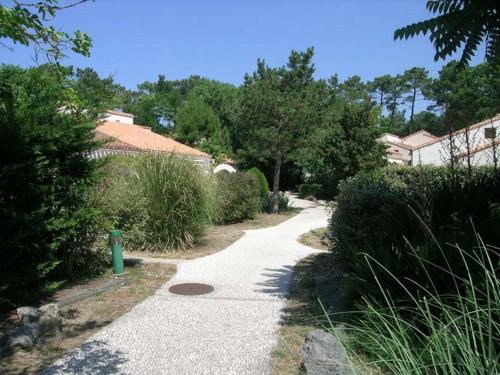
[[43, 199, 327, 375]]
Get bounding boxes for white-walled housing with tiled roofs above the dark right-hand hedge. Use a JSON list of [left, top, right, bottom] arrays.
[[381, 114, 500, 166]]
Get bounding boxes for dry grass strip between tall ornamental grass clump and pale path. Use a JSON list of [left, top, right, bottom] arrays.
[[125, 208, 300, 259]]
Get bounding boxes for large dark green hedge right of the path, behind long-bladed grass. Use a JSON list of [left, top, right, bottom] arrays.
[[329, 167, 500, 306]]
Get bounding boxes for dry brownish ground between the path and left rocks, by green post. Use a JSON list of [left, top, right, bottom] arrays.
[[0, 264, 175, 375]]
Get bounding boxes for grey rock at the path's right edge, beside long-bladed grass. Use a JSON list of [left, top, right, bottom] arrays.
[[302, 331, 358, 375]]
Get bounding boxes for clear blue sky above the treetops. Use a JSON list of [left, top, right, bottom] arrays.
[[0, 0, 480, 88]]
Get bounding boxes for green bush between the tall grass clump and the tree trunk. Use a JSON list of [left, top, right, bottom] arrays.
[[216, 172, 261, 224]]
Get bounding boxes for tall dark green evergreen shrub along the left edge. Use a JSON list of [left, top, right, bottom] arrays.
[[0, 65, 100, 301]]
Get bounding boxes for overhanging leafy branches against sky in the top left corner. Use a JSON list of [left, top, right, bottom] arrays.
[[0, 0, 92, 60]]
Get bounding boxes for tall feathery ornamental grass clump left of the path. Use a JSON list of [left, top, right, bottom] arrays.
[[135, 155, 215, 251]]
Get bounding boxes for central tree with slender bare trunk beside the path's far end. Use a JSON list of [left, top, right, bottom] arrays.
[[238, 48, 326, 212]]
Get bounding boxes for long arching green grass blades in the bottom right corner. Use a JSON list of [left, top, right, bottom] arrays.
[[334, 236, 500, 375]]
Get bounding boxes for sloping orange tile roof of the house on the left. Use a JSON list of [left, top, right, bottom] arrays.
[[95, 121, 210, 158]]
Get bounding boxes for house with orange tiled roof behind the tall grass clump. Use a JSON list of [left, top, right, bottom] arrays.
[[92, 111, 213, 165]]
